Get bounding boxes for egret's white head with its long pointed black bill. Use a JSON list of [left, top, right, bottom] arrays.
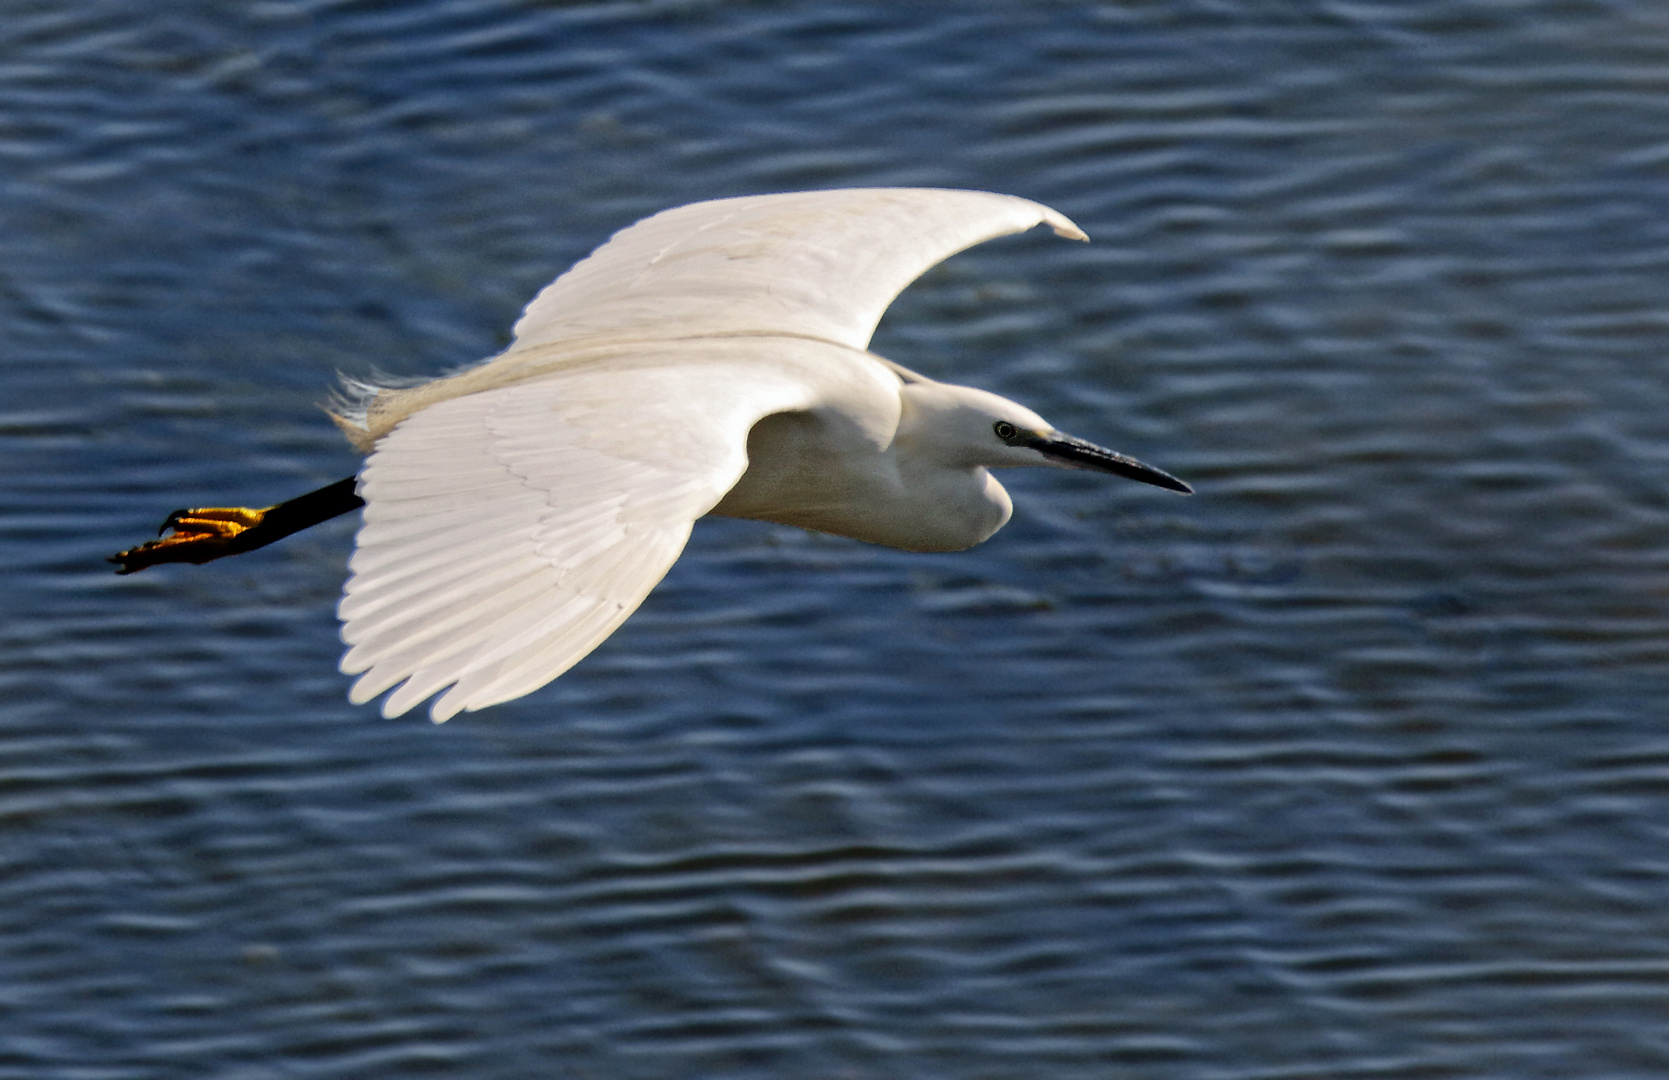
[[898, 381, 1193, 494]]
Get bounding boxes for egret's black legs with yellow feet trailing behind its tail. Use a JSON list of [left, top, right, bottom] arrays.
[[110, 476, 366, 574]]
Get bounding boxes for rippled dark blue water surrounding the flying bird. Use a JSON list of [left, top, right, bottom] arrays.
[[0, 0, 1669, 1080]]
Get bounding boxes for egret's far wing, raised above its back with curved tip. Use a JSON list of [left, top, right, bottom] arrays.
[[507, 187, 1085, 356]]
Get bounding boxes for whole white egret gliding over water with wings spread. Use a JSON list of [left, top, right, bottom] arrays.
[[113, 189, 1190, 723]]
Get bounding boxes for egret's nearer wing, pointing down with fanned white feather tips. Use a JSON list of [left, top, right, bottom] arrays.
[[339, 342, 814, 723]]
